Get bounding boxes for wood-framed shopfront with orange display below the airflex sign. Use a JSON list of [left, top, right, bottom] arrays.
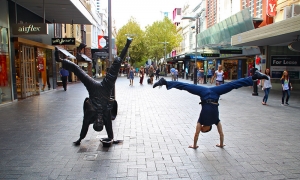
[[13, 37, 55, 99]]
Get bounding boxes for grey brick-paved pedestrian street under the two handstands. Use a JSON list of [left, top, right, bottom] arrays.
[[0, 77, 300, 180]]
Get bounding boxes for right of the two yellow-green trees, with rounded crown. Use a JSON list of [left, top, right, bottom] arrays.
[[145, 17, 182, 63]]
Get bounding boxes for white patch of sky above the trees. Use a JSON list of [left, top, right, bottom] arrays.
[[108, 0, 189, 30]]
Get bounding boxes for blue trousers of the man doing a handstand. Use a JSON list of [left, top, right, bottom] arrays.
[[167, 77, 253, 100]]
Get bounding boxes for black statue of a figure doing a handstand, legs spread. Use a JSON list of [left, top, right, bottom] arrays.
[[55, 38, 132, 146]]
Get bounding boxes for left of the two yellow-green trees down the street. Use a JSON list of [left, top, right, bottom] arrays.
[[116, 17, 146, 65]]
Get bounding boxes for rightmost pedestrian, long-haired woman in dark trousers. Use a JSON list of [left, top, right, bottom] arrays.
[[280, 71, 293, 106]]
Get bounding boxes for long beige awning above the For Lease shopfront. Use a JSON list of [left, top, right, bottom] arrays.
[[231, 16, 300, 46]]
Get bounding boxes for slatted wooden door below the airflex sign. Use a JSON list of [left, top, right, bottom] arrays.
[[20, 45, 36, 98]]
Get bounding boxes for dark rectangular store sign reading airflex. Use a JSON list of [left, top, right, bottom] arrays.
[[11, 23, 48, 35]]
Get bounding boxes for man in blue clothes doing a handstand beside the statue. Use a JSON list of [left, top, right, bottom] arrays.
[[153, 71, 268, 149]]
